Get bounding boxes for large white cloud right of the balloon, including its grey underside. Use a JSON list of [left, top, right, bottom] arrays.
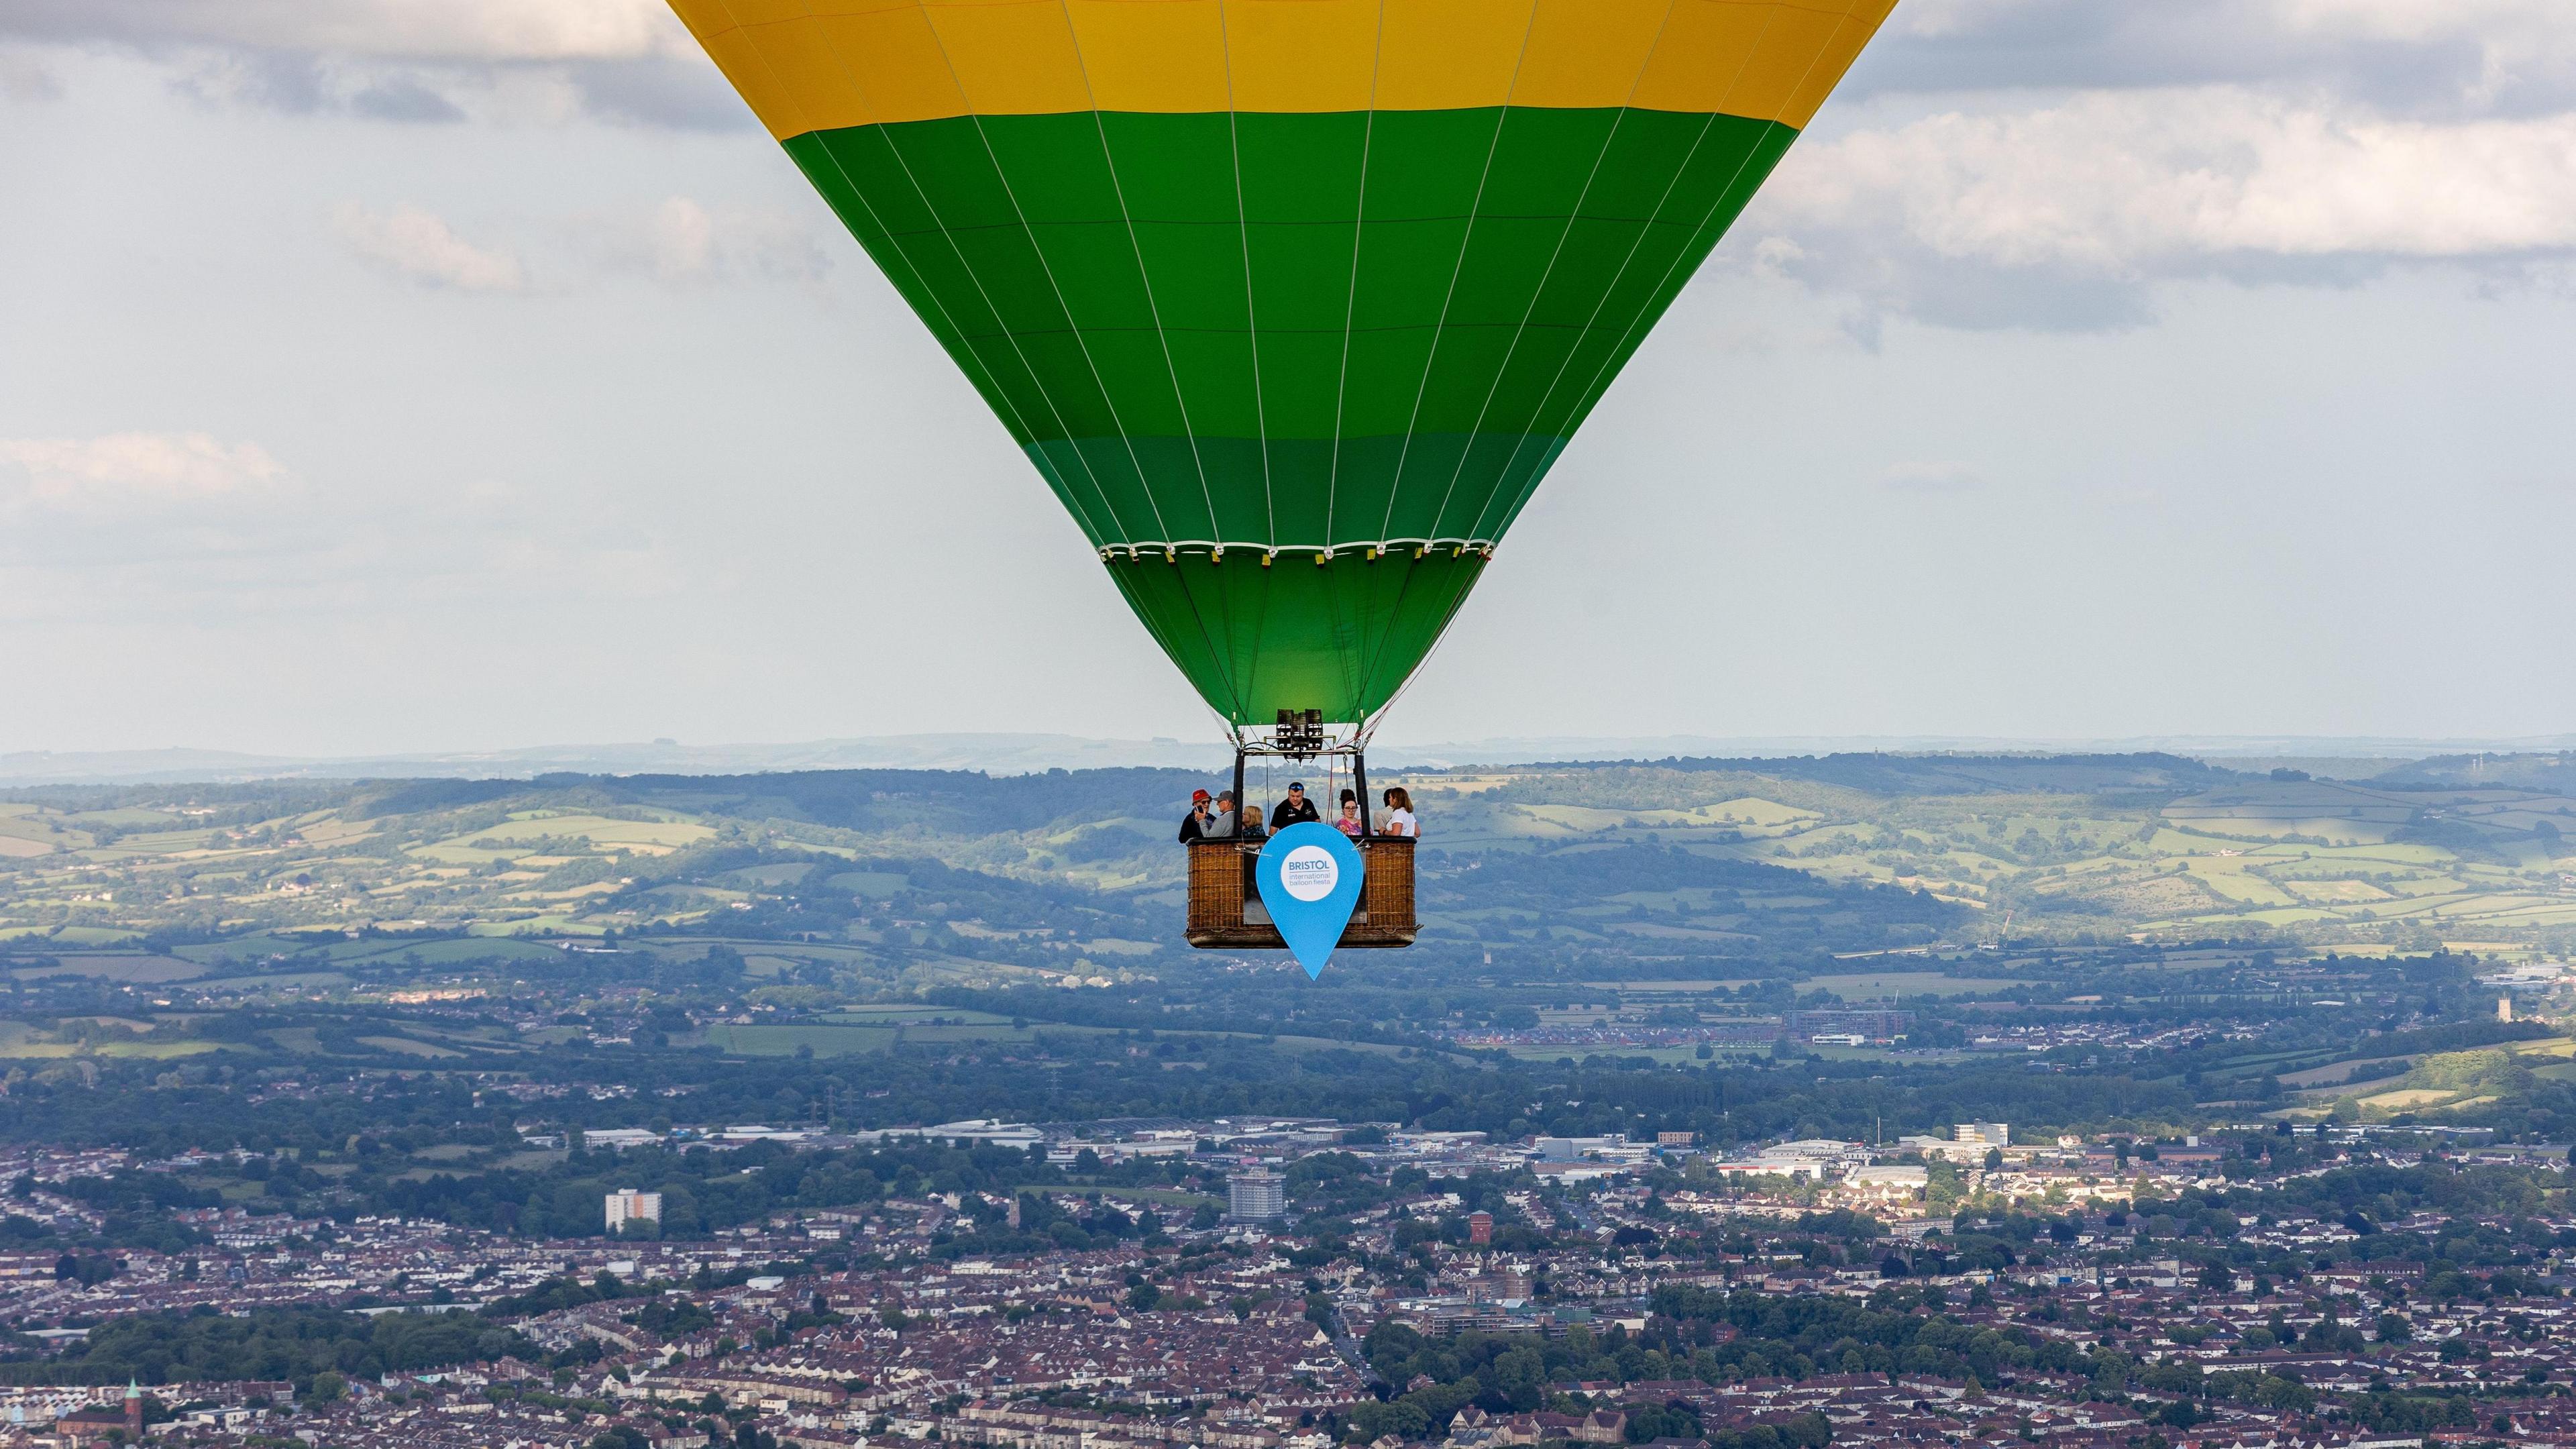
[[1752, 85, 2576, 332]]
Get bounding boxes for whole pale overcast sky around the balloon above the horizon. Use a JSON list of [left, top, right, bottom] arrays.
[[0, 0, 2576, 753]]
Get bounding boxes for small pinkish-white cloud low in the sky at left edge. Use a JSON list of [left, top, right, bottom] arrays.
[[0, 433, 288, 516]]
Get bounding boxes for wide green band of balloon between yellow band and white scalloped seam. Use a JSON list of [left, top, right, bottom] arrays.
[[788, 108, 1793, 544]]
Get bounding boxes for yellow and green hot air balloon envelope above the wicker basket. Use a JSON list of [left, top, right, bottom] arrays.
[[672, 0, 1896, 944]]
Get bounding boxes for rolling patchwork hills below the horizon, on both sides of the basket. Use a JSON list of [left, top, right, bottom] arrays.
[[0, 755, 2576, 964]]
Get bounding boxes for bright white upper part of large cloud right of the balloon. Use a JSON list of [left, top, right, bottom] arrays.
[[1764, 88, 2576, 276]]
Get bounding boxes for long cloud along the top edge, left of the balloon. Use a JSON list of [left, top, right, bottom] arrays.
[[0, 0, 693, 62]]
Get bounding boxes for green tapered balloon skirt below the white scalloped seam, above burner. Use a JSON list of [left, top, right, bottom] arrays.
[[1110, 549, 1484, 724]]
